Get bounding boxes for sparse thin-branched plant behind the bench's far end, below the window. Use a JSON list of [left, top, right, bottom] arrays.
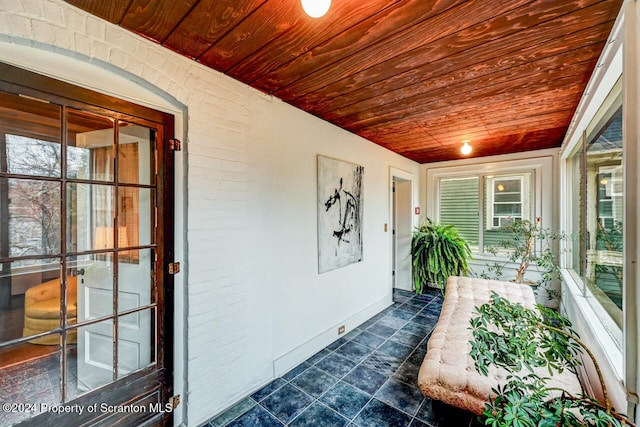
[[480, 218, 565, 299]]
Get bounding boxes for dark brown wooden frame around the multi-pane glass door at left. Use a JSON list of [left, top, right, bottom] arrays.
[[0, 62, 175, 426]]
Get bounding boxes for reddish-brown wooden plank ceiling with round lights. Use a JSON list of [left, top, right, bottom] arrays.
[[67, 0, 622, 163]]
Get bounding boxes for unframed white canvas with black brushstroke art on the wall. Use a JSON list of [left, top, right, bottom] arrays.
[[318, 156, 364, 273]]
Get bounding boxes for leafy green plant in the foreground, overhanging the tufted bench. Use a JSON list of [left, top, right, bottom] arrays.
[[470, 292, 634, 427]]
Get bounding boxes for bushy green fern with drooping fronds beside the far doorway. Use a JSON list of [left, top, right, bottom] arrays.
[[411, 218, 471, 294]]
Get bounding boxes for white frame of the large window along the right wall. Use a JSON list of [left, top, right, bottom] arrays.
[[559, 2, 638, 414]]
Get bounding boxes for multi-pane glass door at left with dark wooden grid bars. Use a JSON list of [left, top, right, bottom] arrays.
[[0, 77, 165, 426]]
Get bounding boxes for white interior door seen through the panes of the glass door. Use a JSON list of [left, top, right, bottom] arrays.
[[67, 111, 155, 394]]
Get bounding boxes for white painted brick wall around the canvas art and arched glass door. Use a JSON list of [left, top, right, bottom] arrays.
[[0, 0, 418, 426]]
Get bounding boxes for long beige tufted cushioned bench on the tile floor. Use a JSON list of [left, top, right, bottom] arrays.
[[418, 277, 582, 415]]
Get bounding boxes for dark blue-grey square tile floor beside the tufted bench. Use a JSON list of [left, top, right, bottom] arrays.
[[206, 290, 481, 427]]
